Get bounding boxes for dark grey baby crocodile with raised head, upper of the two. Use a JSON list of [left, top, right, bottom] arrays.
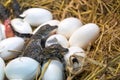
[[23, 24, 57, 62]]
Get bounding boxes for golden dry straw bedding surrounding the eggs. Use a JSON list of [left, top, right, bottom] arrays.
[[1, 0, 120, 80]]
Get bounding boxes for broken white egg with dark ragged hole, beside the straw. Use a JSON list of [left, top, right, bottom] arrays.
[[64, 47, 86, 68]]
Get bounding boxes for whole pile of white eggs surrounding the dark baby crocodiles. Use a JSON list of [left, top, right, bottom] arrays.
[[0, 8, 100, 80]]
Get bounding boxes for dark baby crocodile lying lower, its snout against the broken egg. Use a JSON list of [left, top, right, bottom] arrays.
[[40, 44, 68, 63]]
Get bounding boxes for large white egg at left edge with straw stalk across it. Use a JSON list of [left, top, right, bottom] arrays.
[[0, 37, 24, 60]]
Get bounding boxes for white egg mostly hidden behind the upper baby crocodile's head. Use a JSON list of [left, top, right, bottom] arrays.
[[33, 20, 60, 34]]
